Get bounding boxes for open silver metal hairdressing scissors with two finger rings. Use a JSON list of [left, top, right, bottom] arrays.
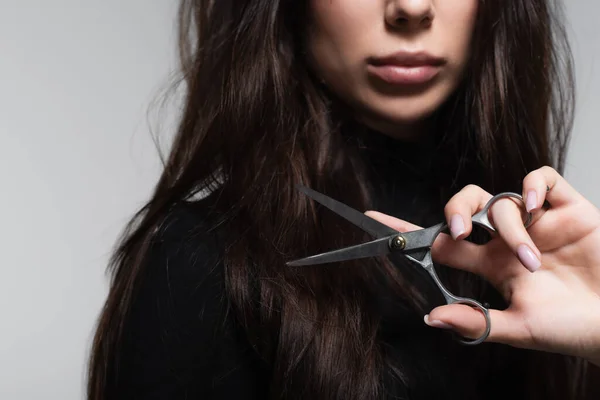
[[287, 185, 532, 345]]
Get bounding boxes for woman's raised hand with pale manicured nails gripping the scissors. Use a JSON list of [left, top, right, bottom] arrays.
[[366, 167, 600, 365]]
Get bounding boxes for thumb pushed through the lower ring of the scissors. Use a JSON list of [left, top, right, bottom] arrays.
[[424, 304, 529, 346]]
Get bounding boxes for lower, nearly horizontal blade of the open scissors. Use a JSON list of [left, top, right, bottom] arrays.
[[287, 237, 390, 267]]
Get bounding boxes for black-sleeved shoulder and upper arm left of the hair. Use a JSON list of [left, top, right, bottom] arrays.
[[119, 199, 266, 399]]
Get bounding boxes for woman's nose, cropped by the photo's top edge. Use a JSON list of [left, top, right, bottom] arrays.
[[385, 0, 434, 30]]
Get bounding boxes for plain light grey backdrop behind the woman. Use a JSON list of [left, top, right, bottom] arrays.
[[0, 0, 600, 400]]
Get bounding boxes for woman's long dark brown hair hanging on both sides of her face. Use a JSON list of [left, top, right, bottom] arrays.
[[88, 0, 596, 400]]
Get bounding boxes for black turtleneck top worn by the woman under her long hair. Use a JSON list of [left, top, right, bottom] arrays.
[[113, 135, 525, 400]]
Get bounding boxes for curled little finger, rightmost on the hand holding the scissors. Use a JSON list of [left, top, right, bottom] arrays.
[[523, 167, 581, 211]]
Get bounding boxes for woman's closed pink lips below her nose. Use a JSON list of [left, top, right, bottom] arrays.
[[368, 51, 446, 85]]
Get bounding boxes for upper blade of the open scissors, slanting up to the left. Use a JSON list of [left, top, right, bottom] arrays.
[[296, 185, 398, 238]]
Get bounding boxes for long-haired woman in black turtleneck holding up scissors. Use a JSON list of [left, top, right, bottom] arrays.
[[88, 0, 600, 400]]
